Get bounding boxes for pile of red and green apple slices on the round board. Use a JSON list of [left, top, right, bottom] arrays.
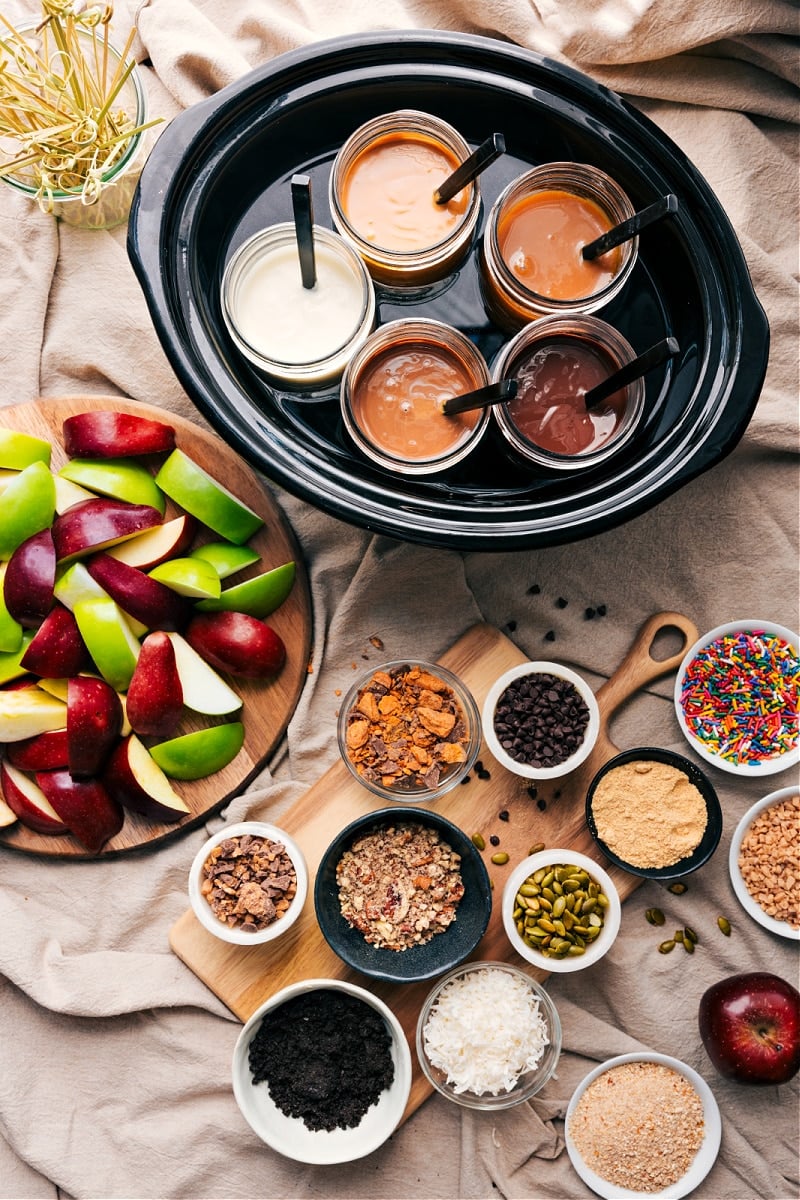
[[0, 410, 295, 853]]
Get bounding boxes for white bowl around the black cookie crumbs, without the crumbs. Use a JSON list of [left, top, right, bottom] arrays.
[[227, 979, 411, 1165]]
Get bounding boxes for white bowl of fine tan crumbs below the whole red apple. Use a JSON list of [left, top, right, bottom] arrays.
[[565, 1054, 722, 1200]]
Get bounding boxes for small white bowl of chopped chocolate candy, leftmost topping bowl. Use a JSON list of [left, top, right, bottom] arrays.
[[188, 821, 308, 946]]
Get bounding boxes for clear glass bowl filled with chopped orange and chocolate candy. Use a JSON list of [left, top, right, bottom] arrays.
[[338, 659, 481, 804]]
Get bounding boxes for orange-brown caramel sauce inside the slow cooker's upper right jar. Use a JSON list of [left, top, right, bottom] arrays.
[[498, 190, 621, 300]]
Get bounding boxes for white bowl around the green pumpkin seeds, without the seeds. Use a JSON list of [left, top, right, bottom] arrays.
[[503, 847, 622, 974]]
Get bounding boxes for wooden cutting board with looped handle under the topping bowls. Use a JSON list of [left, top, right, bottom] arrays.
[[169, 612, 698, 1116]]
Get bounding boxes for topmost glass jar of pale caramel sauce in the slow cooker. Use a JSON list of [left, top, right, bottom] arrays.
[[330, 109, 481, 289]]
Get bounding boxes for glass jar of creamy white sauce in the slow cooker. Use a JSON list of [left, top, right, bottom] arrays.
[[221, 221, 375, 388]]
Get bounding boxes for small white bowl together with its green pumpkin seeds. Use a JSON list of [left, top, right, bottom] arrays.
[[503, 847, 622, 973]]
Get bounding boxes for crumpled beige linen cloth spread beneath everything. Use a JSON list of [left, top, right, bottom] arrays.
[[0, 0, 800, 1200]]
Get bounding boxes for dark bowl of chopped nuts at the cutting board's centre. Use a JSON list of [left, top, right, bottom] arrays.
[[314, 808, 492, 983]]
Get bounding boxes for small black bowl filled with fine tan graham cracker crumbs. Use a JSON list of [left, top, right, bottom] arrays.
[[587, 746, 722, 880]]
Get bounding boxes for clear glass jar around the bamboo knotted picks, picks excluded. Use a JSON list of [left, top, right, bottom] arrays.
[[0, 24, 151, 229]]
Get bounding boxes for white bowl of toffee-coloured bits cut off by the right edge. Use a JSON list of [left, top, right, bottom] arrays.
[[728, 786, 800, 941]]
